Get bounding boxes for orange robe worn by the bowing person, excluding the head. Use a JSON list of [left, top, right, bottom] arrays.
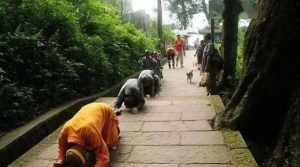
[[57, 103, 119, 167]]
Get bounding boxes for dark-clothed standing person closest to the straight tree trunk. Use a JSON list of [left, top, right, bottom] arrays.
[[205, 46, 224, 95]]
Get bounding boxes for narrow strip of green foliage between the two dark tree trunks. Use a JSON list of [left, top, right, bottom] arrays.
[[236, 27, 247, 78]]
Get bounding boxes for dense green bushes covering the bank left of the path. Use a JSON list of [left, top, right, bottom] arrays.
[[0, 0, 155, 131]]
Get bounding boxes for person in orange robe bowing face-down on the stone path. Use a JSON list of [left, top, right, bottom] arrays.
[[53, 103, 120, 167]]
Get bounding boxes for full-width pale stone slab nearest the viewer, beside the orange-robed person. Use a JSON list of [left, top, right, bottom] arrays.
[[123, 146, 230, 164]]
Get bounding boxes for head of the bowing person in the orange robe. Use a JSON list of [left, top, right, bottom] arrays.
[[64, 145, 86, 167]]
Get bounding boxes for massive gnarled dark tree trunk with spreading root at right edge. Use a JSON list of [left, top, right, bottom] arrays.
[[218, 0, 300, 167]]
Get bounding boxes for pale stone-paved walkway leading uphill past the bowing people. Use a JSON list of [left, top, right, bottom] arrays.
[[10, 52, 230, 167]]
